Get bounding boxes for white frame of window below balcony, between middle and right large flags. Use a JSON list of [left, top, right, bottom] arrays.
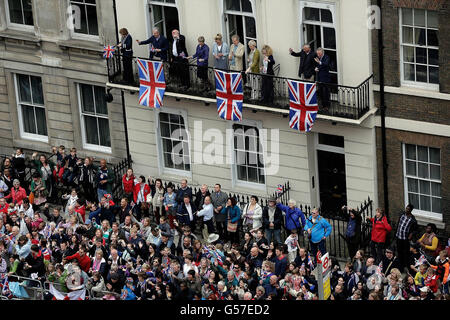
[[228, 119, 267, 192]]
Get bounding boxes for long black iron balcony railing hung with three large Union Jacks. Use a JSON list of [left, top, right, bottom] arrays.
[[107, 54, 373, 121]]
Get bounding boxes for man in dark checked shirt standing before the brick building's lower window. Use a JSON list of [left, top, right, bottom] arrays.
[[395, 204, 417, 271]]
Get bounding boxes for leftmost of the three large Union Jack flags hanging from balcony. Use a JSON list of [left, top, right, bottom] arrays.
[[137, 59, 166, 108]]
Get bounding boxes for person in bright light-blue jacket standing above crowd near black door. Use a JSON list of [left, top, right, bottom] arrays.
[[305, 208, 333, 258]]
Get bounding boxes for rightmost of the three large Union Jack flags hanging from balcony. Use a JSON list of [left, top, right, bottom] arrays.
[[287, 80, 319, 132]]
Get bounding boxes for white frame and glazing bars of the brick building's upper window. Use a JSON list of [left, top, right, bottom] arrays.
[[398, 8, 441, 91]]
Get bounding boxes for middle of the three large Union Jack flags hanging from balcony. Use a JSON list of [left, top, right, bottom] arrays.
[[214, 70, 244, 121]]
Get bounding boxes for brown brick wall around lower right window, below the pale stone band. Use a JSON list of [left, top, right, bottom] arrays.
[[377, 128, 450, 233]]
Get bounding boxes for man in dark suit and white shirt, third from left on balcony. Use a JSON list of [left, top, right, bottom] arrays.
[[169, 29, 190, 89]]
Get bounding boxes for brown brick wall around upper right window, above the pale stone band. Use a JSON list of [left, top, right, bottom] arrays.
[[372, 0, 450, 93]]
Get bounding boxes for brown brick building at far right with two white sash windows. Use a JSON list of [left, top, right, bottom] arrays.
[[372, 0, 450, 233]]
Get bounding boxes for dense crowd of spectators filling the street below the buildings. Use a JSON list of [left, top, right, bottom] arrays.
[[0, 146, 450, 300]]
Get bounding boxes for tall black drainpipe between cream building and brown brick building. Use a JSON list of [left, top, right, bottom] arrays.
[[377, 0, 389, 217]]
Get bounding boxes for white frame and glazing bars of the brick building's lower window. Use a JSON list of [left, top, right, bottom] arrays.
[[402, 143, 443, 222]]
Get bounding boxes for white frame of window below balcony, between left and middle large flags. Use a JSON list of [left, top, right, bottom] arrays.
[[155, 107, 193, 178]]
